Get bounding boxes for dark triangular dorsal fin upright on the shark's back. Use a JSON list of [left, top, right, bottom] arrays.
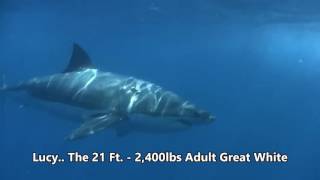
[[63, 43, 94, 73]]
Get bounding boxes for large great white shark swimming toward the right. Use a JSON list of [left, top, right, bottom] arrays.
[[0, 44, 215, 140]]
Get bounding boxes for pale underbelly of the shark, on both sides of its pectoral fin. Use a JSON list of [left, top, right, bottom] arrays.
[[9, 95, 189, 134]]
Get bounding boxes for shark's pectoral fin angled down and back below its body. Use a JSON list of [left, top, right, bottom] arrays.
[[66, 113, 126, 140]]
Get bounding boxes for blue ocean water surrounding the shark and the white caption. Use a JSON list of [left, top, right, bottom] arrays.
[[0, 0, 320, 180]]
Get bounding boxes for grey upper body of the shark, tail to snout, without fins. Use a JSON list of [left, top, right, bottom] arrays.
[[12, 69, 212, 121]]
